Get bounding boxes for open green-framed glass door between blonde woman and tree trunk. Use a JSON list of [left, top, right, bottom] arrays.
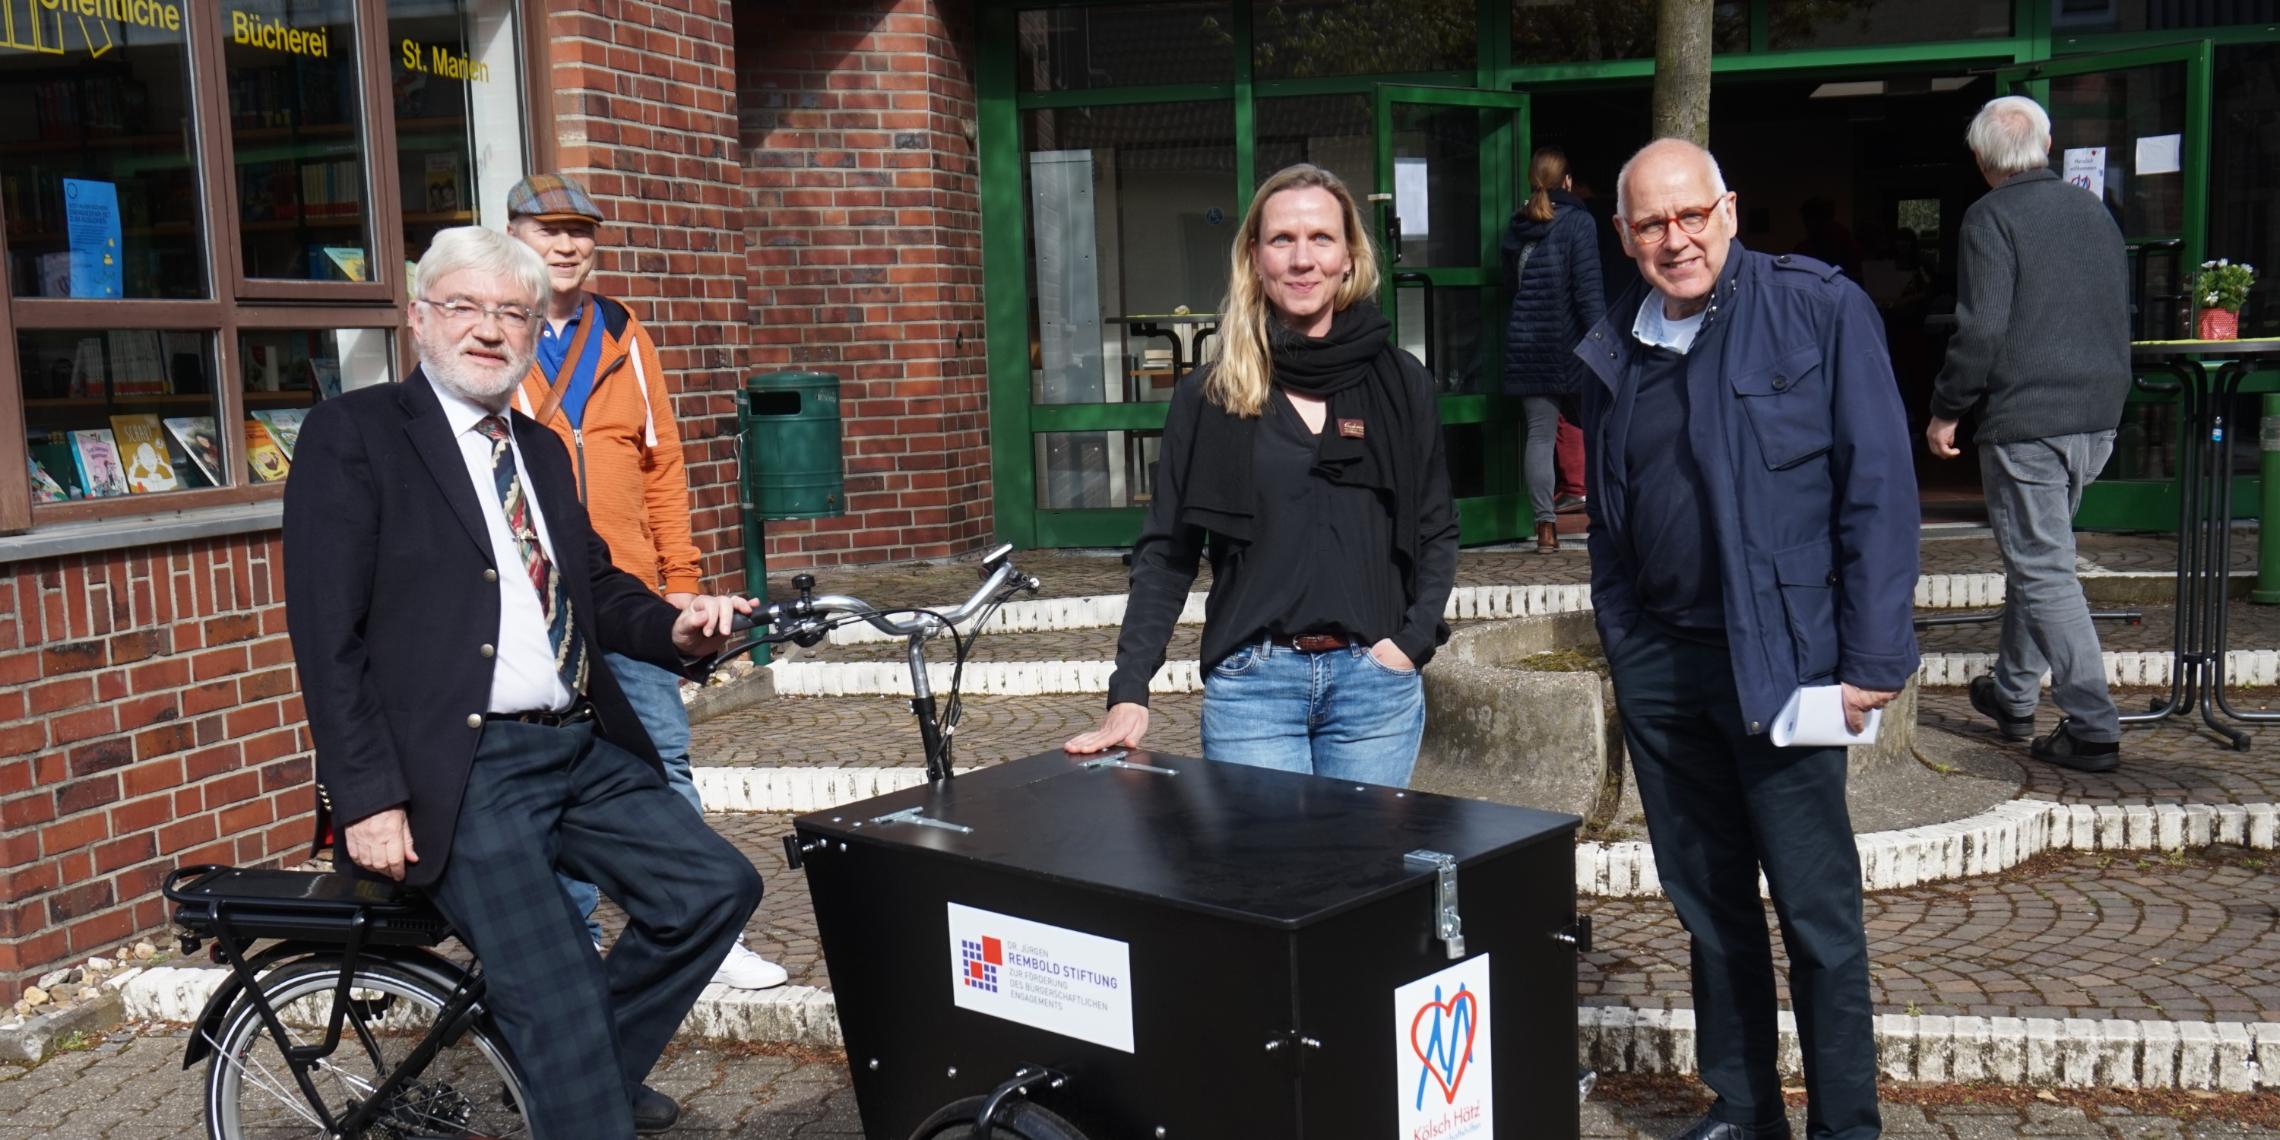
[[1370, 84, 1534, 545]]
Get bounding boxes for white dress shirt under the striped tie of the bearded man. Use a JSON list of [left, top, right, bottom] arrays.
[[431, 381, 579, 714]]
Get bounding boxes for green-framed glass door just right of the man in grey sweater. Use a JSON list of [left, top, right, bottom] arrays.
[[1995, 41, 2212, 531]]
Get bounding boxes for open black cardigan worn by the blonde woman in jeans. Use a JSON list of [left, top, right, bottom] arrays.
[[1108, 353, 1457, 705]]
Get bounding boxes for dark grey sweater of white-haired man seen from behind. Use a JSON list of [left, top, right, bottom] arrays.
[[1931, 169, 2130, 442]]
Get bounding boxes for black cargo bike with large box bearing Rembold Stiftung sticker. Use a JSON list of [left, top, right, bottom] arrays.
[[166, 547, 1589, 1140]]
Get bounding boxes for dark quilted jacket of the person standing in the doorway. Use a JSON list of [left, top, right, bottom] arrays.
[[1505, 198, 1607, 397]]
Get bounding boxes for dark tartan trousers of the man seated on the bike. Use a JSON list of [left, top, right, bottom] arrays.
[[429, 720, 759, 1140]]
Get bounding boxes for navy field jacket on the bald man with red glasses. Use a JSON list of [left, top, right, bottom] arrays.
[[1575, 242, 1920, 734]]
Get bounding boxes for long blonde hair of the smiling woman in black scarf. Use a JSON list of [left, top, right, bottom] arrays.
[[1204, 162, 1377, 417]]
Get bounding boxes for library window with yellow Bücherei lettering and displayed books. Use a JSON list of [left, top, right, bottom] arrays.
[[0, 0, 527, 531]]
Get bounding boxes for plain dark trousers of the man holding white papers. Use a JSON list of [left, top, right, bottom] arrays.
[[1610, 622, 1883, 1140]]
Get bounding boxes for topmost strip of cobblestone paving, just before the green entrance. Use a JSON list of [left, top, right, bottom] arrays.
[[768, 529, 2257, 606]]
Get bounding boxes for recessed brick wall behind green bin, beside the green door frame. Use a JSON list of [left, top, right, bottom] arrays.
[[736, 0, 994, 570]]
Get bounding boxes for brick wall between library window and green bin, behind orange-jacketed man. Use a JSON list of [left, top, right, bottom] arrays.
[[534, 0, 764, 591]]
